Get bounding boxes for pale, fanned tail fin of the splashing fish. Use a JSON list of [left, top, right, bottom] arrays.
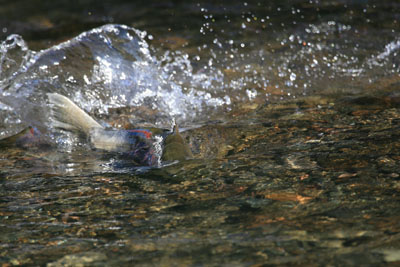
[[47, 93, 103, 135]]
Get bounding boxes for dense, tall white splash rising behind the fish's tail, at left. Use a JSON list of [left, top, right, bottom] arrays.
[[0, 25, 229, 138]]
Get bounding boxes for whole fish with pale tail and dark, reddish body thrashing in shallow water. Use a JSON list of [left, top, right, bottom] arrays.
[[48, 93, 192, 166]]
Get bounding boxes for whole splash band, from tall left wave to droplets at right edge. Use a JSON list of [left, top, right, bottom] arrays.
[[0, 18, 399, 139]]
